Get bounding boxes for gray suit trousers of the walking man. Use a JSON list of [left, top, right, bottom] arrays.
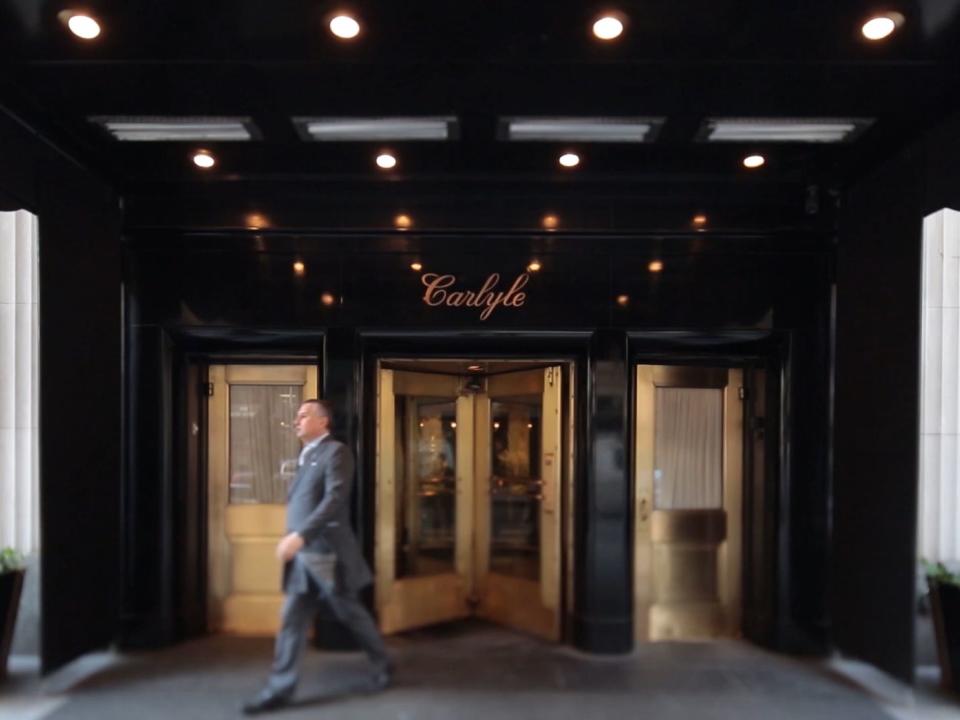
[[267, 592, 390, 698]]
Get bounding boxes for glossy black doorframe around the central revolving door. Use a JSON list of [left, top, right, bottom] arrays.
[[355, 329, 594, 643]]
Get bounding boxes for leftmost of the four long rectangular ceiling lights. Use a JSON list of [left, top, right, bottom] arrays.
[[88, 115, 260, 142]]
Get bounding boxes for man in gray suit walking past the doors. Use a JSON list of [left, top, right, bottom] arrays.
[[243, 400, 392, 715]]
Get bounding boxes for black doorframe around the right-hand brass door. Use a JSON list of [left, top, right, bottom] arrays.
[[627, 330, 792, 648]]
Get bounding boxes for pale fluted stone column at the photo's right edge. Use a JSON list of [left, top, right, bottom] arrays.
[[905, 210, 960, 563]]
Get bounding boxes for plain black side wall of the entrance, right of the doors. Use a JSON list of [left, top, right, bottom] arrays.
[[831, 109, 960, 680]]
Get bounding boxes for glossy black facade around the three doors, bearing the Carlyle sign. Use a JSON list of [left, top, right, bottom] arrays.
[[121, 229, 834, 653]]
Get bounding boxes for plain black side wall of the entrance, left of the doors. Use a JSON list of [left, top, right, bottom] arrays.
[[0, 108, 122, 672]]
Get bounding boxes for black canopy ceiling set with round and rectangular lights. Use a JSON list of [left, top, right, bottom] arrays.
[[0, 0, 960, 207]]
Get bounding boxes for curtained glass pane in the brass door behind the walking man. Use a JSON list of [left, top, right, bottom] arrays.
[[230, 385, 303, 504]]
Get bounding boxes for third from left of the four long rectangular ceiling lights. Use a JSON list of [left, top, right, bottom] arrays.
[[498, 117, 663, 143]]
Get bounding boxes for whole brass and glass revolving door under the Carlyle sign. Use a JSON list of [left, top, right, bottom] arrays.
[[376, 363, 563, 639]]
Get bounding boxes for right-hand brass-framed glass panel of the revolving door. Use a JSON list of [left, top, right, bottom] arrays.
[[476, 367, 563, 640]]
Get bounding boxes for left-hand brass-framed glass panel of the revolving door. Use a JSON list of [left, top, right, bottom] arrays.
[[375, 368, 473, 633]]
